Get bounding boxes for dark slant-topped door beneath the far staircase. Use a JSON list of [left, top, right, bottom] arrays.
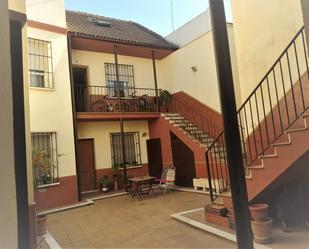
[[170, 132, 196, 187]]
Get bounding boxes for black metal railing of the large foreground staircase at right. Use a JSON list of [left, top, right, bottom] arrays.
[[206, 27, 309, 201]]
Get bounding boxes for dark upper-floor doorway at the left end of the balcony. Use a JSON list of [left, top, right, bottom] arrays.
[[73, 67, 89, 112]]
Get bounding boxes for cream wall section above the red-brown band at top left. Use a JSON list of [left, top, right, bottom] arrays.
[[26, 0, 66, 28]]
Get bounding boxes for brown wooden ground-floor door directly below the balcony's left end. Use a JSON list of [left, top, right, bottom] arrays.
[[78, 139, 96, 192]]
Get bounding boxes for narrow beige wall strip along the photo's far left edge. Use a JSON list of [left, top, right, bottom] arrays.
[[0, 1, 18, 248]]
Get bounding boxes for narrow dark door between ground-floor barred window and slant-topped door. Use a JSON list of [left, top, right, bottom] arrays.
[[147, 138, 162, 178]]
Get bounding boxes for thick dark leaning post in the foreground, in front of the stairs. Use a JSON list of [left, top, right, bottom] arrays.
[[209, 0, 253, 249]]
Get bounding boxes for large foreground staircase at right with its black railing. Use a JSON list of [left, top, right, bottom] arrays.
[[205, 27, 309, 227]]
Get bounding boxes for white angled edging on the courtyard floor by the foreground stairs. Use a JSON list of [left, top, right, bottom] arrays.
[[171, 208, 271, 249]]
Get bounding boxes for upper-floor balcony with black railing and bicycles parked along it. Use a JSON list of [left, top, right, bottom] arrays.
[[74, 85, 160, 121]]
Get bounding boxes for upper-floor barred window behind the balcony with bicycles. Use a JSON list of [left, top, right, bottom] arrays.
[[105, 63, 135, 97]]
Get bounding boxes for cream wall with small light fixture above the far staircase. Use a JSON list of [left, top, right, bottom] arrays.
[[158, 24, 240, 112]]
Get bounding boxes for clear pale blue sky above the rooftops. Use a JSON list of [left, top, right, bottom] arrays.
[[65, 0, 232, 36]]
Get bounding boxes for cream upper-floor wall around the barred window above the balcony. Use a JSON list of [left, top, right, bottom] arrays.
[[72, 50, 155, 89]]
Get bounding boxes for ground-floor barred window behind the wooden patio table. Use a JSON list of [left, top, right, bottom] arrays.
[[111, 132, 141, 166]]
